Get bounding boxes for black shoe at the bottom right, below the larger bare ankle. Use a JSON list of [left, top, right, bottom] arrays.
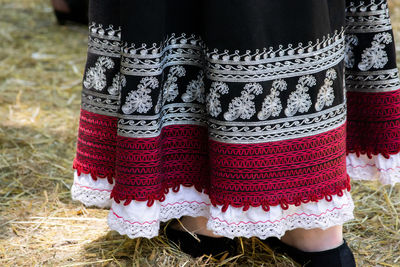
[[263, 237, 356, 267]]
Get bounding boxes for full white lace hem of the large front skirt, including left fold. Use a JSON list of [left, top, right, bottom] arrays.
[[72, 174, 354, 239]]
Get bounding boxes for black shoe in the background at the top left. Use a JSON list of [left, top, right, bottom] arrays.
[[54, 0, 89, 25]]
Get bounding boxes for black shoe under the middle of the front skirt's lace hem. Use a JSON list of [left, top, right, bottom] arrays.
[[165, 223, 236, 258]]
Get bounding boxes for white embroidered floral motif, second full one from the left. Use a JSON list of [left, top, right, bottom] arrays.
[[122, 77, 158, 114]]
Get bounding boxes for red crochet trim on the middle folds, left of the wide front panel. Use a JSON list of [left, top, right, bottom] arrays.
[[111, 125, 210, 206]]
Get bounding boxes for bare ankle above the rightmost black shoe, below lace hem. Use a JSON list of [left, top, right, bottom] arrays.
[[281, 225, 343, 252]]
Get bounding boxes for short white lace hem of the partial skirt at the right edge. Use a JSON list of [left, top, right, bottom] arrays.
[[346, 153, 400, 185]]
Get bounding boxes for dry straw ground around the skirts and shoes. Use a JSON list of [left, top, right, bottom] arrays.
[[0, 0, 400, 266]]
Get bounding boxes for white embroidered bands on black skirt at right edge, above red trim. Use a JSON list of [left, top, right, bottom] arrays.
[[344, 0, 400, 93]]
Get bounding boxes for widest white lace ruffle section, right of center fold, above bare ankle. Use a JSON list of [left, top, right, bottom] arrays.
[[207, 191, 354, 239]]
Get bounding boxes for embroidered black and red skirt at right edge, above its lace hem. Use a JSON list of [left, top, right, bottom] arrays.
[[345, 0, 400, 158]]
